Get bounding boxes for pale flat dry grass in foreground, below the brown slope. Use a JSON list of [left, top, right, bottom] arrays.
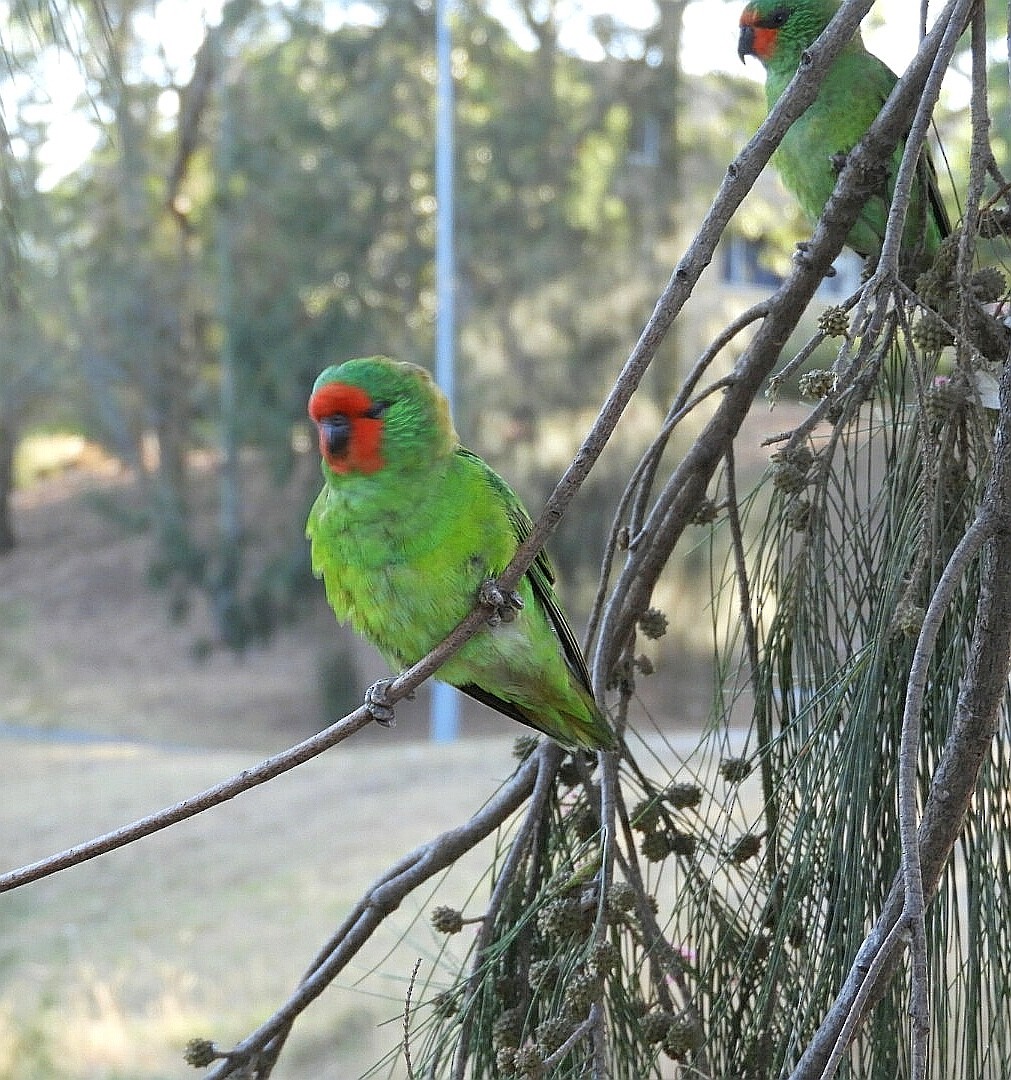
[[0, 738, 514, 1080]]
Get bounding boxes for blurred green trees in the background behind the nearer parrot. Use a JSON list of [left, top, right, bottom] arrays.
[[0, 0, 773, 649]]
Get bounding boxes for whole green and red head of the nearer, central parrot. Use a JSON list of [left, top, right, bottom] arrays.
[[309, 356, 459, 476]]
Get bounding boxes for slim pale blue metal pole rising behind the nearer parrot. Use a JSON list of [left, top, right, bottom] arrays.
[[429, 0, 460, 742]]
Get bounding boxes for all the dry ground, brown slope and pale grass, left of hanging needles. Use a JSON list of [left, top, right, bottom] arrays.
[[0, 461, 537, 1080]]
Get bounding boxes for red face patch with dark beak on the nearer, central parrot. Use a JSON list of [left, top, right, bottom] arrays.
[[309, 382, 389, 475]]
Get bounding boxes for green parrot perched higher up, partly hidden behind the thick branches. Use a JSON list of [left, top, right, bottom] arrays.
[[738, 0, 951, 275]]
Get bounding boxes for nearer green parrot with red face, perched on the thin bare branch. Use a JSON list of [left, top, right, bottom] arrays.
[[306, 356, 617, 750]]
